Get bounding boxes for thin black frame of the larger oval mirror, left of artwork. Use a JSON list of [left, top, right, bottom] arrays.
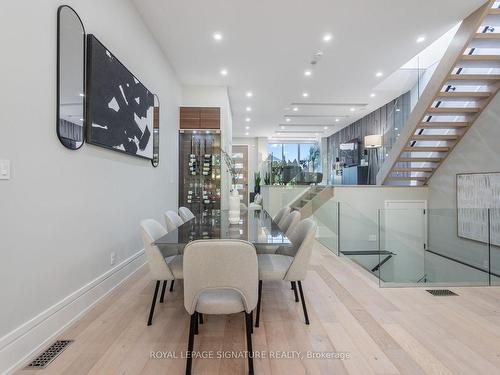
[[56, 5, 87, 151]]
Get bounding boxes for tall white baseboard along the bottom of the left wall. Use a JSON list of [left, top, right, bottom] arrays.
[[0, 250, 145, 374]]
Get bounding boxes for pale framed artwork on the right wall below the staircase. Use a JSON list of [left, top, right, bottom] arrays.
[[457, 172, 500, 246]]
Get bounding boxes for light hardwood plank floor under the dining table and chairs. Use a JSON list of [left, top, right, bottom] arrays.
[[15, 243, 500, 375]]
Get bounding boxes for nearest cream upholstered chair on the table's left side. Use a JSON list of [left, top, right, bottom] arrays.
[[141, 219, 182, 326]]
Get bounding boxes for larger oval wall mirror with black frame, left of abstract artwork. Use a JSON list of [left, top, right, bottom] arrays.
[[56, 5, 85, 150]]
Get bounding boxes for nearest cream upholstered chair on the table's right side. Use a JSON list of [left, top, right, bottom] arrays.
[[255, 218, 317, 327]]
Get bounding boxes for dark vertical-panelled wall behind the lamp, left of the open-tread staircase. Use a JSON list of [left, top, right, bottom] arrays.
[[327, 91, 411, 183]]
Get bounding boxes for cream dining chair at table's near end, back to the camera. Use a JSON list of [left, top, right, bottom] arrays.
[[183, 240, 258, 374]]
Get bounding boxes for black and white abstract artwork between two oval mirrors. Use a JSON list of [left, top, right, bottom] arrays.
[[87, 35, 154, 159]]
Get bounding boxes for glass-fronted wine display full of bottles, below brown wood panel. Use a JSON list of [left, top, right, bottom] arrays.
[[179, 130, 221, 215]]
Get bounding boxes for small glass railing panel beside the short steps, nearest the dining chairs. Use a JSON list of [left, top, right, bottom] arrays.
[[311, 196, 339, 255]]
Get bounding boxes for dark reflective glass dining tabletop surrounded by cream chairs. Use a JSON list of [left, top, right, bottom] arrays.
[[154, 209, 292, 251]]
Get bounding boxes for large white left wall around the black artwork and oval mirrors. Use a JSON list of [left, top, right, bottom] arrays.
[[0, 0, 181, 373]]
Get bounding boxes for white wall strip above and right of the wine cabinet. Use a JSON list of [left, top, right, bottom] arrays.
[[182, 86, 233, 209]]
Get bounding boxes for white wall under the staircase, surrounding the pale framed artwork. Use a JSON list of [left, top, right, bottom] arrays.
[[429, 95, 500, 273]]
